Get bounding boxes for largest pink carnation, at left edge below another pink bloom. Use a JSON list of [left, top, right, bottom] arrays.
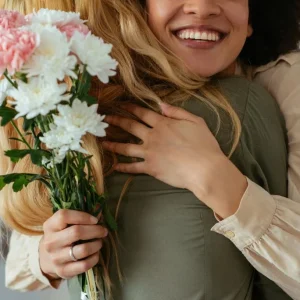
[[0, 29, 39, 76]]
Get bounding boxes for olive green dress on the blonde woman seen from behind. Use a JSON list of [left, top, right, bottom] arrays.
[[69, 77, 291, 300]]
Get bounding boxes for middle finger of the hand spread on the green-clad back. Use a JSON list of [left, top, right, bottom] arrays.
[[105, 116, 150, 140]]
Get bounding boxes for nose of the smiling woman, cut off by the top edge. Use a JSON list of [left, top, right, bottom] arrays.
[[183, 0, 221, 18]]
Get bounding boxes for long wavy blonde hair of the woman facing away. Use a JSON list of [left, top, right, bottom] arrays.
[[0, 0, 241, 296]]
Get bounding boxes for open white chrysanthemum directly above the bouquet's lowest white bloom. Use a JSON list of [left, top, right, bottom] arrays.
[[53, 99, 108, 137]]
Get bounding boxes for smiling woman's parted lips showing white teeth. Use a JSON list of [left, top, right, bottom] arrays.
[[172, 25, 228, 49]]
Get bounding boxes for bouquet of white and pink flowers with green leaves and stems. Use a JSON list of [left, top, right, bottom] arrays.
[[0, 9, 117, 300]]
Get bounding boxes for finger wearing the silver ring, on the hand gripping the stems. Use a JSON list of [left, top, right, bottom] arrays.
[[52, 239, 103, 265]]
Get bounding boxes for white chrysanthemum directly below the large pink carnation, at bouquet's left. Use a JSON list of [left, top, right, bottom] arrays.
[[7, 77, 70, 119]]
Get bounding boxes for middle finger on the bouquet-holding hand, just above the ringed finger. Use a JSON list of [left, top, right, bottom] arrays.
[[44, 225, 108, 253]]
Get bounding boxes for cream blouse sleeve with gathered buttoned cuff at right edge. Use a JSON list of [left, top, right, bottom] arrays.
[[212, 52, 300, 300]]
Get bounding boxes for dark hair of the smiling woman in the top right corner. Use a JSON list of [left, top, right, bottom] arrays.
[[240, 0, 300, 66]]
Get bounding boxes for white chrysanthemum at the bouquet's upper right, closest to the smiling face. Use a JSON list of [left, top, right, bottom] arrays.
[[71, 32, 118, 83]]
